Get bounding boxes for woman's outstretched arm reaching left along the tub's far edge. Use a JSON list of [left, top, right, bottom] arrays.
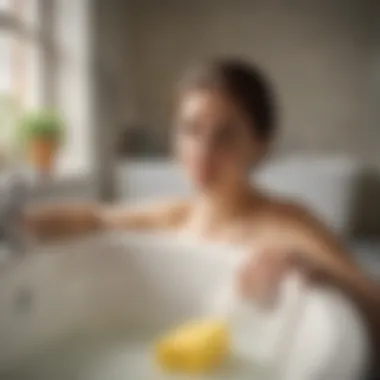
[[25, 200, 188, 240]]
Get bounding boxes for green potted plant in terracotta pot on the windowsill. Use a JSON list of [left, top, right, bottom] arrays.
[[21, 109, 64, 174]]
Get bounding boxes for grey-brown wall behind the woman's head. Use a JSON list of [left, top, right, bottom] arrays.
[[120, 0, 380, 162]]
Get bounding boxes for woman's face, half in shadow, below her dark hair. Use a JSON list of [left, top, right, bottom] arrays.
[[175, 90, 265, 191]]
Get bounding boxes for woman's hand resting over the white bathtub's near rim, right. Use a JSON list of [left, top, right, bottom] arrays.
[[237, 249, 323, 307]]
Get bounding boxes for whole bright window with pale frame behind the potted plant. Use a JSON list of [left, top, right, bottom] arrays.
[[0, 0, 91, 175]]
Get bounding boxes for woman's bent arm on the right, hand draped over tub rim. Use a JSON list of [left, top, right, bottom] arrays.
[[243, 205, 380, 360]]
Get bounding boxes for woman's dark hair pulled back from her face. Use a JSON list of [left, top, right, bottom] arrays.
[[180, 59, 276, 140]]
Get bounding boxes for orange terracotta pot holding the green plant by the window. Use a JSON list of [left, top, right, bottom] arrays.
[[28, 138, 57, 174]]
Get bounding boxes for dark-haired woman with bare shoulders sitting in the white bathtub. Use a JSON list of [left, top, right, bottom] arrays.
[[28, 60, 380, 360]]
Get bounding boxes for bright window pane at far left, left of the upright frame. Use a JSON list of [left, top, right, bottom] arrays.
[[0, 0, 45, 160]]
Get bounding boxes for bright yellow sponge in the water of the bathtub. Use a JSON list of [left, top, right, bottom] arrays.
[[155, 320, 229, 374]]
